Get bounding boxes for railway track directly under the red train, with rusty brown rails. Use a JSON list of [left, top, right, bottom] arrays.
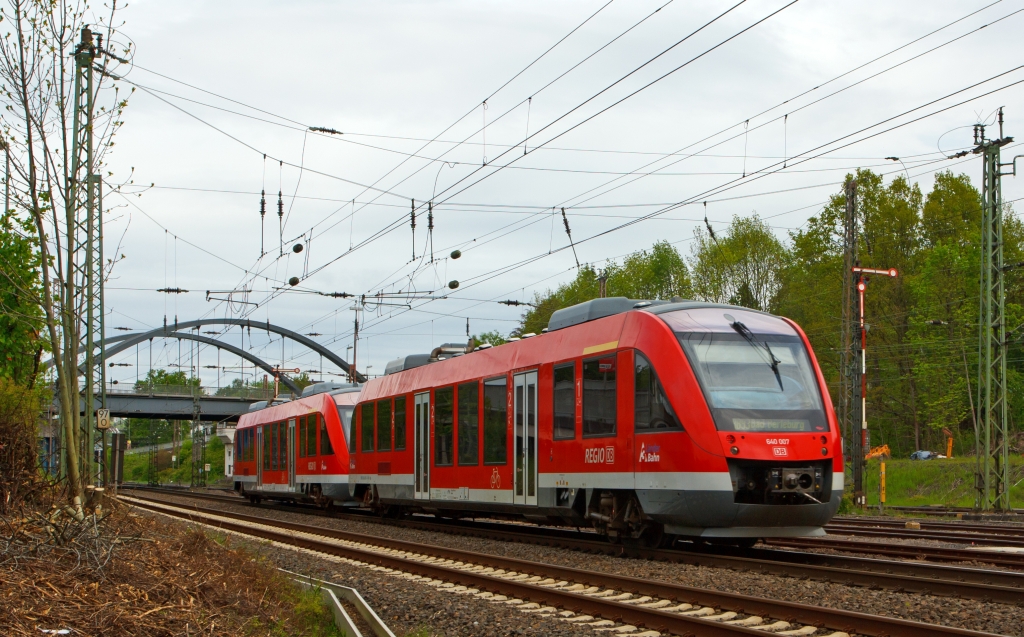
[[121, 493, 1024, 604]]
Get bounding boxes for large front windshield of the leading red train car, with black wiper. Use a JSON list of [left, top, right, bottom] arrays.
[[660, 307, 828, 433]]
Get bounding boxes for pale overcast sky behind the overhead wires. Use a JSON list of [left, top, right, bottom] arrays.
[[104, 0, 1024, 386]]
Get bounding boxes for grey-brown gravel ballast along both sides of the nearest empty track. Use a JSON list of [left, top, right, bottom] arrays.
[[138, 494, 1024, 637]]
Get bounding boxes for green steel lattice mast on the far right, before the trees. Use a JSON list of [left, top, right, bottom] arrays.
[[971, 108, 1017, 511]]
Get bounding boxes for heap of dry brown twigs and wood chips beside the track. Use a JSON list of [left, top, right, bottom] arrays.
[[0, 504, 327, 637]]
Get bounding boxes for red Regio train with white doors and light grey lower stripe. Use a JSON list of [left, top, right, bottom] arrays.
[[237, 297, 843, 544]]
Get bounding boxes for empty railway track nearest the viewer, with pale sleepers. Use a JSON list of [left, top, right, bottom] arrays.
[[125, 498, 1007, 637]]
